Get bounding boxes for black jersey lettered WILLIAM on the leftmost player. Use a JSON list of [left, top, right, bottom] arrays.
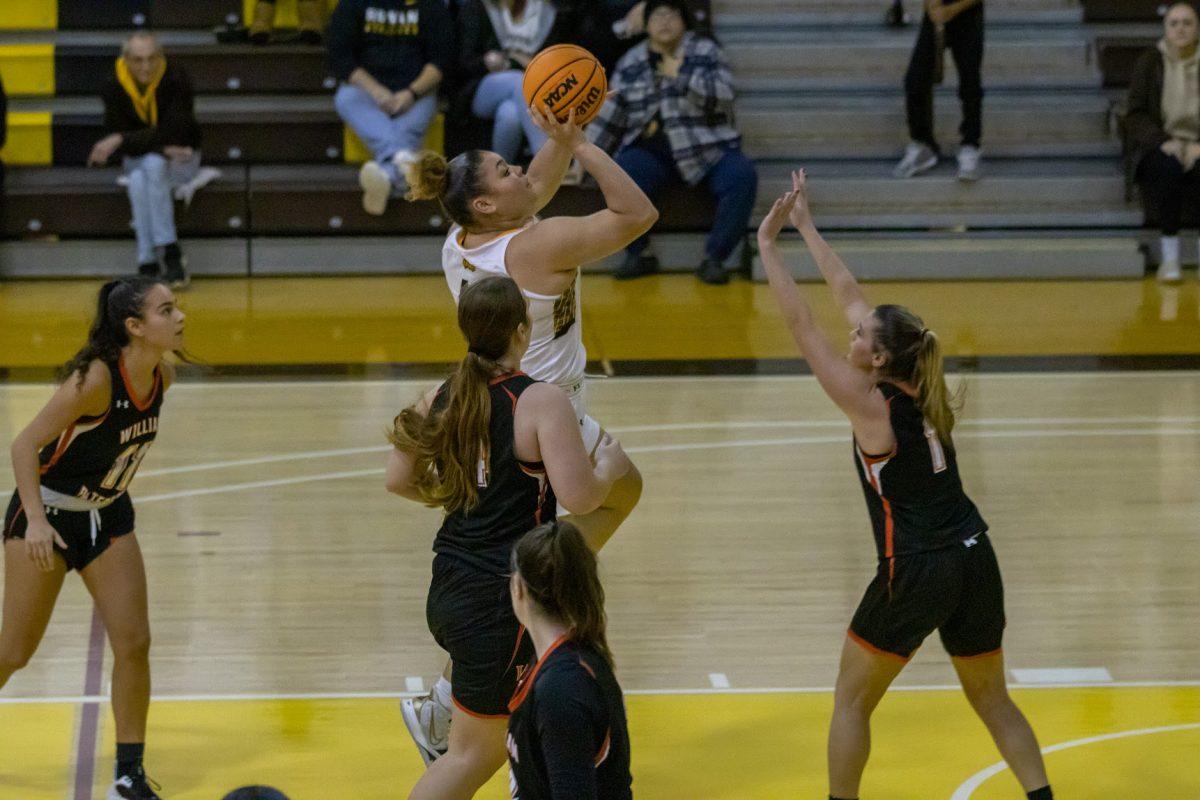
[[38, 360, 163, 504]]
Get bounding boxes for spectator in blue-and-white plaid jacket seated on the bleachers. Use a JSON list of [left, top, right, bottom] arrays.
[[588, 0, 758, 283]]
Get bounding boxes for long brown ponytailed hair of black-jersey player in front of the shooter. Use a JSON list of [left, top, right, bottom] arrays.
[[388, 276, 529, 513]]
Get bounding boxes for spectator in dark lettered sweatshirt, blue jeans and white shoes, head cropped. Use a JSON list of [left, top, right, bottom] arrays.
[[328, 0, 455, 215]]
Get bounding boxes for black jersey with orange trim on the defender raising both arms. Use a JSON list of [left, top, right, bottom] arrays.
[[854, 383, 988, 559]]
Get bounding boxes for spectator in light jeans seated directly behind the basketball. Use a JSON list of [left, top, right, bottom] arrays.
[[450, 0, 582, 163]]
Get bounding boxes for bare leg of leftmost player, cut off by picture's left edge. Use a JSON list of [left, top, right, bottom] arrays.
[[0, 539, 67, 688]]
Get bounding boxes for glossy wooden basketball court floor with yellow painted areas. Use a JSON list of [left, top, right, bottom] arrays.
[[0, 277, 1200, 800]]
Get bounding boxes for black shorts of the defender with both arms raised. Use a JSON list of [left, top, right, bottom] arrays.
[[850, 534, 1004, 661]]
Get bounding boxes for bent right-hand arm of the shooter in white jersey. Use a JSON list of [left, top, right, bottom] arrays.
[[509, 109, 659, 272]]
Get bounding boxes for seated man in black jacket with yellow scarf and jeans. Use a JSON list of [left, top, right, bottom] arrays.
[[88, 31, 220, 288]]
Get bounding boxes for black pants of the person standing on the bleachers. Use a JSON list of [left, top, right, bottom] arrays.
[[904, 4, 983, 152]]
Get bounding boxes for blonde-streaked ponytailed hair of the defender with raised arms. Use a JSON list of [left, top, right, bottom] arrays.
[[875, 306, 962, 445]]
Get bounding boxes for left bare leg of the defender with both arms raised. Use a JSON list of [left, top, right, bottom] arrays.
[[828, 636, 906, 800]]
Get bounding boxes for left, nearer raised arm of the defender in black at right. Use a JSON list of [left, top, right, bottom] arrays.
[[758, 190, 893, 452]]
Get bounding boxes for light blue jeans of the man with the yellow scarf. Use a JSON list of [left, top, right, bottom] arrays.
[[122, 152, 200, 264]]
